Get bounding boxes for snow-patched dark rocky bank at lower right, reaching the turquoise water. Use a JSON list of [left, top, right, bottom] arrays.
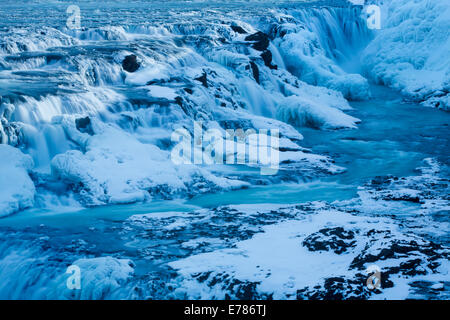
[[167, 159, 450, 300]]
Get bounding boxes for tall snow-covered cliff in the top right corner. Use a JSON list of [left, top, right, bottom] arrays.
[[362, 0, 450, 110]]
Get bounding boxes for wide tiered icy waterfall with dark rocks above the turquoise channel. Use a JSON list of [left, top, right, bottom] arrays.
[[0, 1, 370, 212]]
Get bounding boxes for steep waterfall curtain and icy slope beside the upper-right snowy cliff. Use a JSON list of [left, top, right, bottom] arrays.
[[274, 8, 371, 100]]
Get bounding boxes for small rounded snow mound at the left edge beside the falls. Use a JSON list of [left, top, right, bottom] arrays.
[[0, 144, 36, 217]]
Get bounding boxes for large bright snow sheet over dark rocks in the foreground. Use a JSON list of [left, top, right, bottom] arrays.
[[169, 203, 448, 299]]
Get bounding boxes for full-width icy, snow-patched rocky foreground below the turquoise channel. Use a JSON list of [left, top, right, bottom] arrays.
[[0, 159, 450, 300]]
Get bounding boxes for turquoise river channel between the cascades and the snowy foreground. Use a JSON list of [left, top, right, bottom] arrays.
[[0, 86, 450, 228]]
